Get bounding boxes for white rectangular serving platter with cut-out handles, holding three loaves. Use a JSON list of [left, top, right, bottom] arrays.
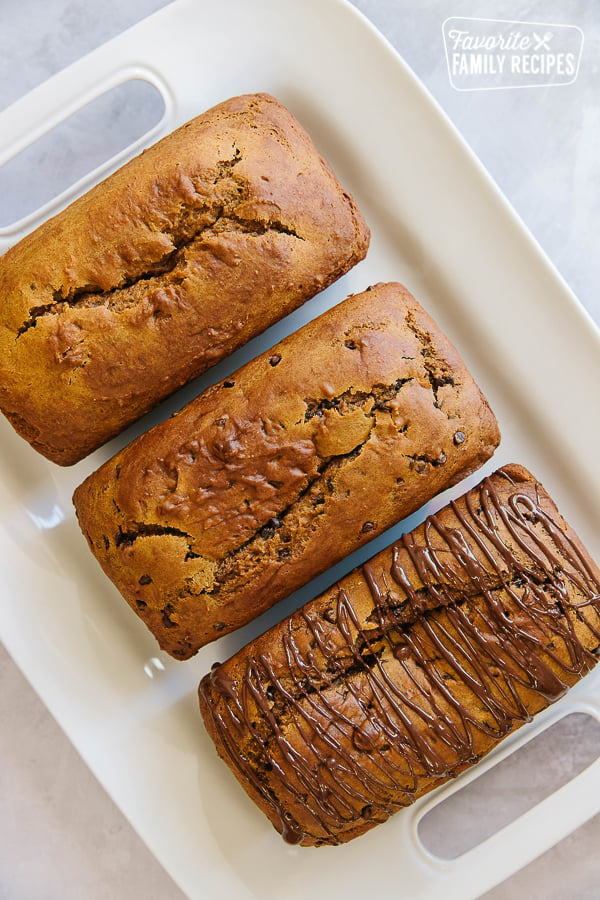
[[0, 0, 600, 900]]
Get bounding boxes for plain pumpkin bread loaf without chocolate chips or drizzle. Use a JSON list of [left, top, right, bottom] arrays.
[[0, 94, 369, 465]]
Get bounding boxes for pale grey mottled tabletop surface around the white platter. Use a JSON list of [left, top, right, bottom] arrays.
[[0, 0, 600, 900]]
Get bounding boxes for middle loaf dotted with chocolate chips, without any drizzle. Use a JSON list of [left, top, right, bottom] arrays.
[[74, 284, 499, 659]]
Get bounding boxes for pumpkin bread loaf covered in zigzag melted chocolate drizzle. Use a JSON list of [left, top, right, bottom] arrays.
[[199, 466, 600, 846]]
